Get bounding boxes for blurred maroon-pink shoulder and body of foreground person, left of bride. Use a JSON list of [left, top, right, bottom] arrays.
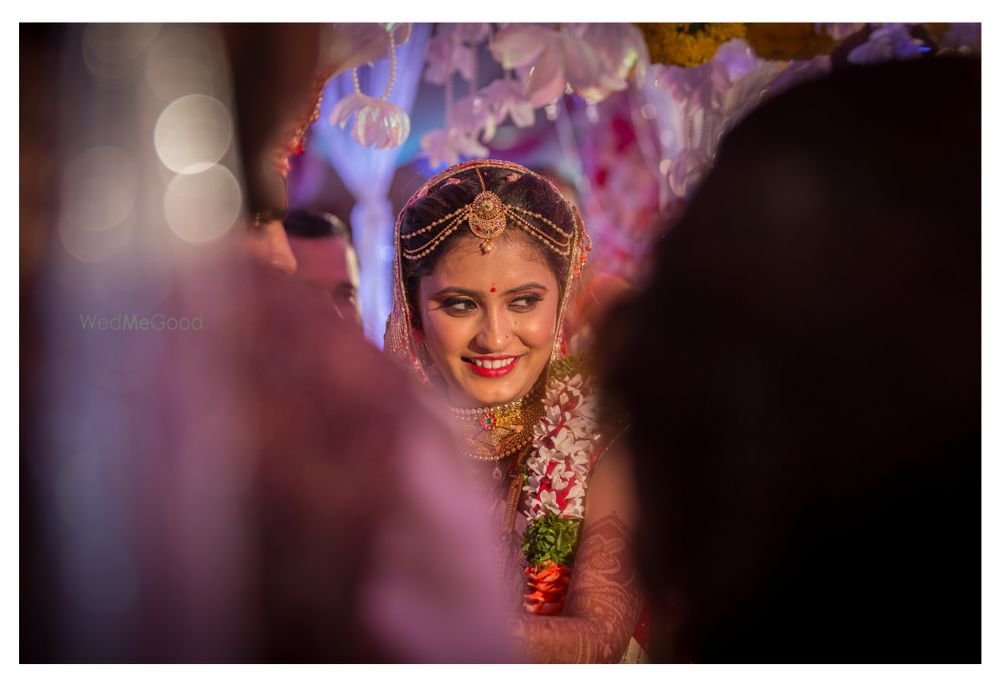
[[245, 256, 512, 662]]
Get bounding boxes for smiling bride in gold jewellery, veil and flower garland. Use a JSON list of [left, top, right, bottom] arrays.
[[386, 160, 641, 662]]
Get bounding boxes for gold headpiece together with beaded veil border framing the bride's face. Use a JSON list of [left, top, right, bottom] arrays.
[[385, 160, 591, 382]]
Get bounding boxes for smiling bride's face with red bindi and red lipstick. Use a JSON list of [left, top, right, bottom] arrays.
[[418, 236, 559, 406]]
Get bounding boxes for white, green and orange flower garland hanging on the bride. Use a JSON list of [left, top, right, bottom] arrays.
[[522, 374, 597, 615]]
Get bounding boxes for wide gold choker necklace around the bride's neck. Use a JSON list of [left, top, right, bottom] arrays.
[[449, 374, 545, 462]]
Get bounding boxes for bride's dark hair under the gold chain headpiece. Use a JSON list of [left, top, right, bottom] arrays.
[[398, 167, 574, 325]]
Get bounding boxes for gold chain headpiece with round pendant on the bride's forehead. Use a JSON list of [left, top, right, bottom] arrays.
[[399, 160, 576, 260]]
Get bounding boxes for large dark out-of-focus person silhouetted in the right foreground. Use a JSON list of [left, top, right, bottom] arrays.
[[604, 59, 981, 663]]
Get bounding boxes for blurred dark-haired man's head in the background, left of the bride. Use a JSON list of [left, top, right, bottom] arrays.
[[285, 210, 361, 319]]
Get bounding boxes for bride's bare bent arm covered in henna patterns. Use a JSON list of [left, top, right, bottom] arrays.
[[514, 441, 642, 662]]
